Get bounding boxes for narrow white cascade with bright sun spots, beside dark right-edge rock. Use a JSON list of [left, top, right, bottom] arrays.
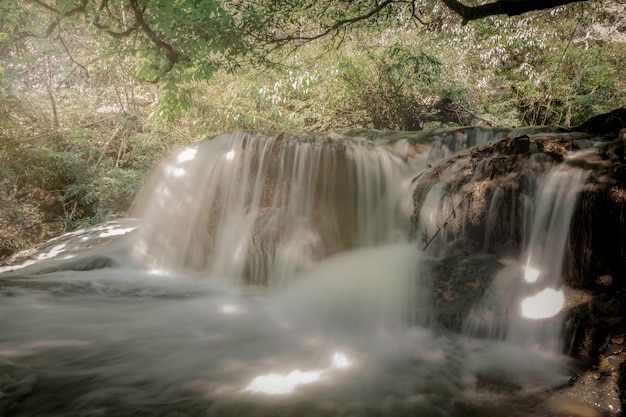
[[464, 164, 588, 353]]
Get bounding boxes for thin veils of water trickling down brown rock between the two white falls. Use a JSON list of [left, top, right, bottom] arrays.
[[418, 150, 554, 256]]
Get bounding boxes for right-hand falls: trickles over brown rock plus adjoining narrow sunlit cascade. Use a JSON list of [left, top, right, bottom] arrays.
[[418, 140, 588, 353]]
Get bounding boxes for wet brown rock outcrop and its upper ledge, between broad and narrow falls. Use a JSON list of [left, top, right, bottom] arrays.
[[412, 133, 590, 255]]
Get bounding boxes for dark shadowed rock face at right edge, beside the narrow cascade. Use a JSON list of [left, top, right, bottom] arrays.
[[563, 150, 626, 368]]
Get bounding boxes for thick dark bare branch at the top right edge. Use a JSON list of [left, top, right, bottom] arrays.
[[441, 0, 586, 24]]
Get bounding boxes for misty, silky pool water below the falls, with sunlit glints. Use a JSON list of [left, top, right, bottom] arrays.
[[0, 244, 569, 417]]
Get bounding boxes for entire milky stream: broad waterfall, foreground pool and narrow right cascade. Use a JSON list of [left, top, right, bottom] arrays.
[[0, 131, 585, 417]]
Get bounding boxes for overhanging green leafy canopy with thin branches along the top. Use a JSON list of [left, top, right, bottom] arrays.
[[0, 0, 592, 119]]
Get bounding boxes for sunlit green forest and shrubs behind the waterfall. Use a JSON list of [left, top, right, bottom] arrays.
[[0, 0, 626, 259]]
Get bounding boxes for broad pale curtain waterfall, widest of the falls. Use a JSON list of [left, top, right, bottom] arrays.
[[132, 132, 420, 286]]
